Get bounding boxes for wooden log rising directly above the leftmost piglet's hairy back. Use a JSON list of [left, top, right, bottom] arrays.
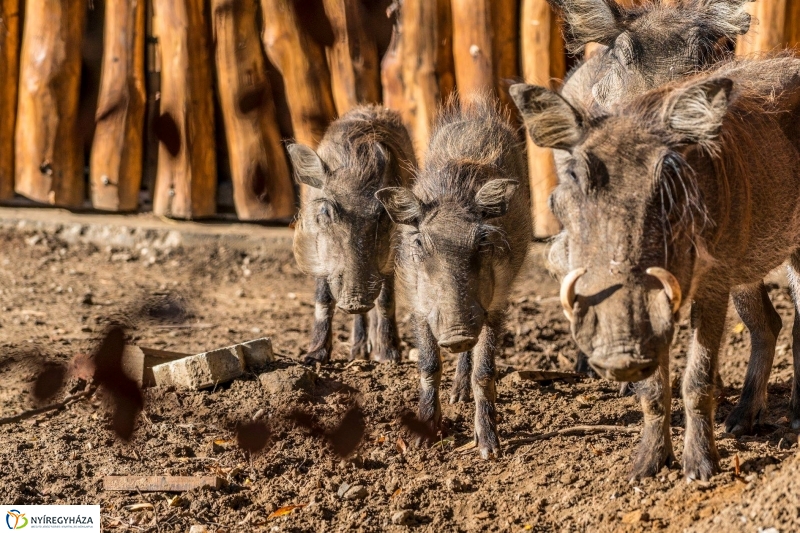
[[323, 0, 381, 115]]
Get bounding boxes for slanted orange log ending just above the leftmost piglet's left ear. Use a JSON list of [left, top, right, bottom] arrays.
[[261, 0, 336, 148]]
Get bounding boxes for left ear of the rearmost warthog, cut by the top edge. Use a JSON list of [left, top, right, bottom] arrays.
[[548, 0, 625, 53]]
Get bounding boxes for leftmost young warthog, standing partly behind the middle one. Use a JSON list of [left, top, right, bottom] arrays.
[[289, 106, 416, 364]]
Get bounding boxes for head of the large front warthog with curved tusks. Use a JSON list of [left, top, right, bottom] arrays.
[[511, 78, 732, 381]]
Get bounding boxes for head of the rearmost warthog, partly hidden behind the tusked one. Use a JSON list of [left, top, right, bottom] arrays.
[[549, 0, 752, 107]]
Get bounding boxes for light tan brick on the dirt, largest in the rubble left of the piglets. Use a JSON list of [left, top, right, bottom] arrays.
[[153, 345, 244, 389]]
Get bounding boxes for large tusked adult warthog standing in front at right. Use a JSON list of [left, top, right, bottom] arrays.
[[512, 58, 800, 479]]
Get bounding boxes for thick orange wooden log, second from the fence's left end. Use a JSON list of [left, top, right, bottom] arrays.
[[15, 0, 86, 207]]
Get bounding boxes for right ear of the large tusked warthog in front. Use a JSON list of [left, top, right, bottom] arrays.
[[664, 78, 733, 143]]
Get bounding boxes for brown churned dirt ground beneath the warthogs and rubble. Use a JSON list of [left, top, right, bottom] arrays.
[[0, 219, 800, 533]]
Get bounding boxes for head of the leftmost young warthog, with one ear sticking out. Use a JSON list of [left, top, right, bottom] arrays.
[[289, 138, 396, 313]]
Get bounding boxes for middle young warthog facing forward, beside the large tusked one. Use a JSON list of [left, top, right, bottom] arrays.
[[378, 98, 531, 457]]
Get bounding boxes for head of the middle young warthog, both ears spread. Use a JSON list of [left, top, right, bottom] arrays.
[[378, 167, 519, 353]]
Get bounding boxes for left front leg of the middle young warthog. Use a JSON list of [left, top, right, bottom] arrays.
[[415, 318, 442, 431]]
